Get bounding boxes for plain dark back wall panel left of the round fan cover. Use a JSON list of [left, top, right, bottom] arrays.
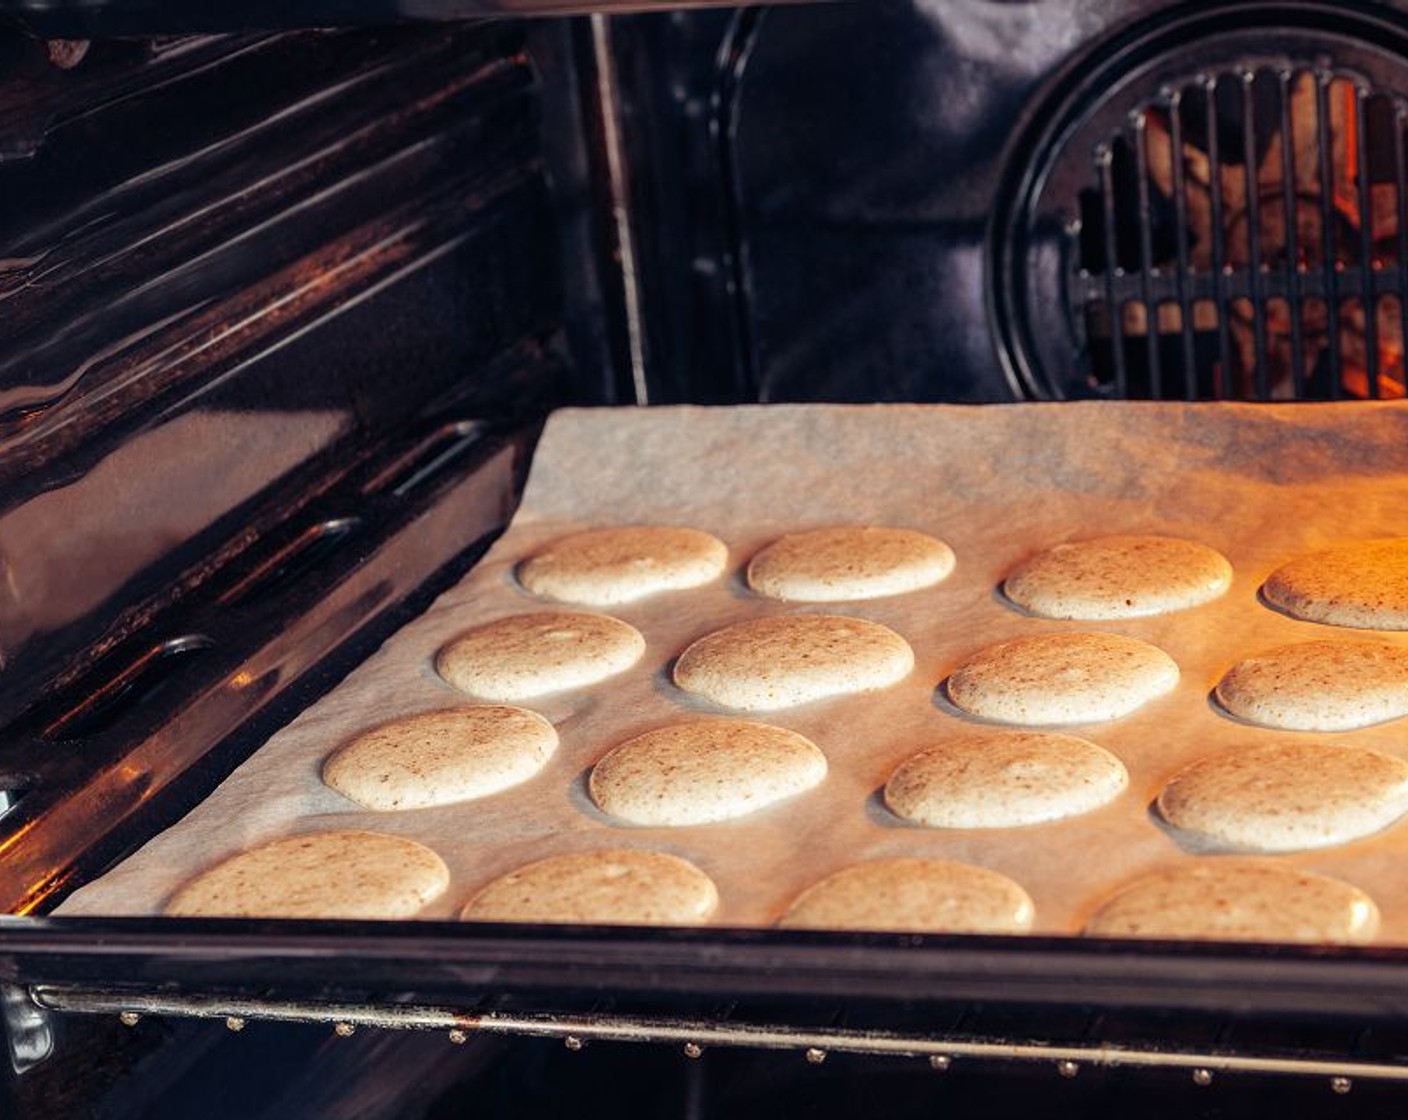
[[571, 0, 1098, 402]]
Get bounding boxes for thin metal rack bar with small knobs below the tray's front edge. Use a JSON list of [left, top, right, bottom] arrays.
[[19, 985, 1408, 1095]]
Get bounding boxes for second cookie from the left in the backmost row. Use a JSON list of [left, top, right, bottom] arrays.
[[748, 525, 953, 603]]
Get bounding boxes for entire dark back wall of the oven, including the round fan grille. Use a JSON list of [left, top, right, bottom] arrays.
[[596, 0, 1408, 402]]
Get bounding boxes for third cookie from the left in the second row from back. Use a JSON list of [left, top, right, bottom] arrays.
[[948, 631, 1178, 726]]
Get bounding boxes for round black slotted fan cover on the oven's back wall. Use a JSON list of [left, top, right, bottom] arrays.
[[988, 3, 1408, 399]]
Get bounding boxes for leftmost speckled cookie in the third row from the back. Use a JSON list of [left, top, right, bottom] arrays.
[[322, 704, 558, 810]]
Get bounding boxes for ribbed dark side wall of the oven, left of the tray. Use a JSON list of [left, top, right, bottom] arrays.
[[0, 23, 588, 738]]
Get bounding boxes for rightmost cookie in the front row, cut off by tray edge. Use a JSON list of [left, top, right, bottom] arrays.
[[1086, 859, 1378, 944]]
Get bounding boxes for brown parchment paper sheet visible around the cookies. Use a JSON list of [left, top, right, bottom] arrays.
[[59, 402, 1408, 944]]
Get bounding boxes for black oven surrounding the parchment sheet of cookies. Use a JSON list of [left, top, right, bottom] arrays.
[[0, 0, 1408, 1117]]
